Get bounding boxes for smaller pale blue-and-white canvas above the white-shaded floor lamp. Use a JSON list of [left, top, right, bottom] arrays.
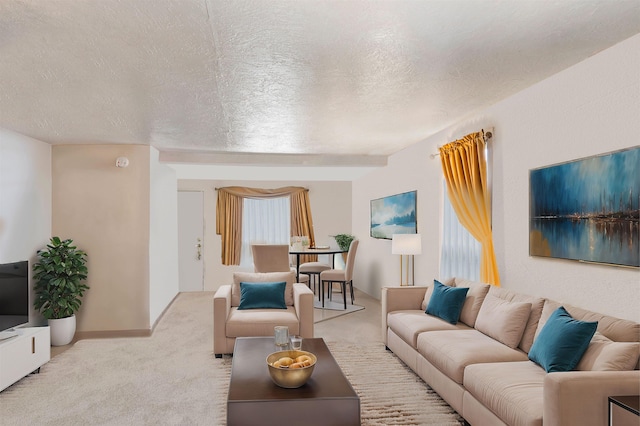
[[371, 191, 417, 240]]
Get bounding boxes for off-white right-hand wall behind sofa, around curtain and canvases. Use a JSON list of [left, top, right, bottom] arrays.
[[353, 35, 640, 321]]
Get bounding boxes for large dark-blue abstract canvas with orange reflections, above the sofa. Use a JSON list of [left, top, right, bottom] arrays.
[[529, 147, 640, 267]]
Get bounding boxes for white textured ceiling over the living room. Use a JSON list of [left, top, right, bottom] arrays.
[[0, 0, 640, 164]]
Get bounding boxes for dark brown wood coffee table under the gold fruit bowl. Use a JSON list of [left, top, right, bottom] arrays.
[[227, 337, 360, 426]]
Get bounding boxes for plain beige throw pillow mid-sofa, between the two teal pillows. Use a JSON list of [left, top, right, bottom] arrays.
[[476, 293, 531, 348]]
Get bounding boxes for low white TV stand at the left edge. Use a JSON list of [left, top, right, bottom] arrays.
[[0, 327, 51, 392]]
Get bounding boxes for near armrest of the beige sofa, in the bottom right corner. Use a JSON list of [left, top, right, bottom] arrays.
[[542, 370, 640, 426]]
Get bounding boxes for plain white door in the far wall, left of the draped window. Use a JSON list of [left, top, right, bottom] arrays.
[[178, 191, 204, 291]]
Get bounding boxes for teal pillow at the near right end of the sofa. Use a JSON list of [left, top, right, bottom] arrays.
[[529, 306, 598, 373]]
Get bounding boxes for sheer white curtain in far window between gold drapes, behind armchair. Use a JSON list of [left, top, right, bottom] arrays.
[[240, 197, 291, 270]]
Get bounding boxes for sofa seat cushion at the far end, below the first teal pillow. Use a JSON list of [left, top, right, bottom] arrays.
[[387, 310, 469, 348]]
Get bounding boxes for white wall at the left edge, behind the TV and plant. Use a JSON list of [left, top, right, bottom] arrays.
[[0, 129, 51, 325]]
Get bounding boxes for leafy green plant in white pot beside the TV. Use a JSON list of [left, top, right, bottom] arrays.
[[33, 237, 89, 346]]
